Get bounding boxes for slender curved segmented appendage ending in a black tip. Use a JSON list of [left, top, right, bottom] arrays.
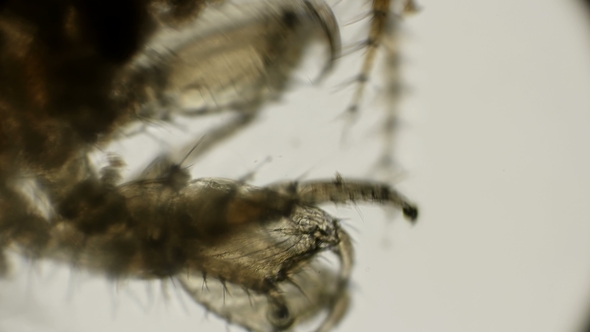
[[269, 176, 418, 223]]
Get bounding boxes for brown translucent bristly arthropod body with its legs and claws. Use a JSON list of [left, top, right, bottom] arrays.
[[0, 0, 417, 331]]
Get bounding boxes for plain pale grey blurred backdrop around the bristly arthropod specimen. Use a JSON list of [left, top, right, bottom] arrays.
[[0, 0, 590, 332]]
